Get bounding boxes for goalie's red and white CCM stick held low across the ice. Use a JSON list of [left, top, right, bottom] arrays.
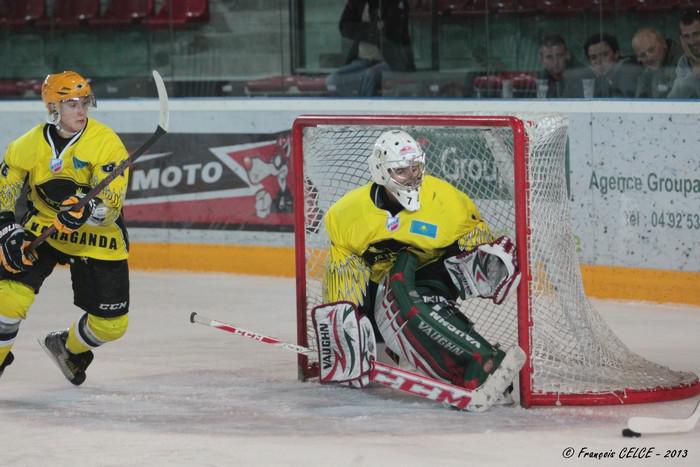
[[190, 312, 524, 412]]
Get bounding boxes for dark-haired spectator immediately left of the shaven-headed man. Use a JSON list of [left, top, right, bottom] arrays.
[[568, 33, 641, 97]]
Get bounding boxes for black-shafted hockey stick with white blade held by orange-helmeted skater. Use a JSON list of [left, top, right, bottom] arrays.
[[25, 70, 170, 256]]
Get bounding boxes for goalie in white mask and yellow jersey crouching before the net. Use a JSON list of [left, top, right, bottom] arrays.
[[314, 130, 524, 410]]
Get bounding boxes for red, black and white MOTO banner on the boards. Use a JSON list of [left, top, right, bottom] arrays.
[[121, 132, 294, 232]]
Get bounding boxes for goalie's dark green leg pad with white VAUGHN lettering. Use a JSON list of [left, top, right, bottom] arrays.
[[375, 252, 505, 389]]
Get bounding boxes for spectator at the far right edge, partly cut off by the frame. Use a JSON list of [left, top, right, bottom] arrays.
[[668, 10, 700, 99]]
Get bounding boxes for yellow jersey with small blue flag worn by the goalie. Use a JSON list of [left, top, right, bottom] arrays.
[[323, 175, 493, 305]]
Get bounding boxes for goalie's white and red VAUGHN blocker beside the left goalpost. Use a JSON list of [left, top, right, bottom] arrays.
[[311, 302, 377, 387]]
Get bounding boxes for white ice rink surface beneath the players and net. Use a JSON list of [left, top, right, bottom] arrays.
[[0, 269, 700, 467]]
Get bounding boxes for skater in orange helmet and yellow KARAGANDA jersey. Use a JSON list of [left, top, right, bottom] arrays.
[[0, 71, 129, 385]]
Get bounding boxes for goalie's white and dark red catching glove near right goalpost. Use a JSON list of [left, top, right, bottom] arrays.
[[444, 236, 520, 305]]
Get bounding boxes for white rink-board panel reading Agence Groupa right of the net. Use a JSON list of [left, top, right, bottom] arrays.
[[569, 114, 700, 272]]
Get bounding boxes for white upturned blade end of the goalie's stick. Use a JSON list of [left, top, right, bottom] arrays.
[[467, 346, 526, 412]]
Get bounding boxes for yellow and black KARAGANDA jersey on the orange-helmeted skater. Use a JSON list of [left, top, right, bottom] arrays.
[[0, 119, 129, 260]]
